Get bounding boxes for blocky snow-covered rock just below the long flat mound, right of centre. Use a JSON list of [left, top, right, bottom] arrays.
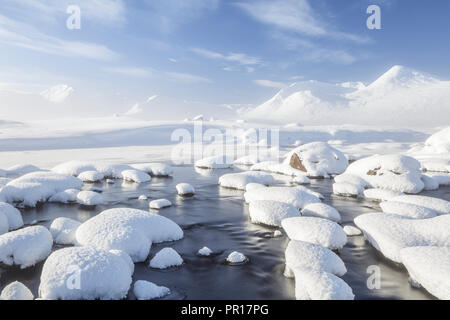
[[249, 200, 300, 227]]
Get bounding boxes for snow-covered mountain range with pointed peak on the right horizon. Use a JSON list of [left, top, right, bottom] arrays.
[[244, 66, 450, 126]]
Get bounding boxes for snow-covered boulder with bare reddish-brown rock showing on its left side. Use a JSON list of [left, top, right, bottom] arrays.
[[284, 142, 348, 178]]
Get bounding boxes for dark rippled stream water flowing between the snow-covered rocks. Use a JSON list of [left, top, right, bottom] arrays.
[[0, 166, 450, 299]]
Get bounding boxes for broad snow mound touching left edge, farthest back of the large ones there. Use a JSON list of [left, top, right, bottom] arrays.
[[0, 172, 83, 207]]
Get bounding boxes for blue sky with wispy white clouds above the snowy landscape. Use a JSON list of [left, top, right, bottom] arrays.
[[0, 0, 450, 120]]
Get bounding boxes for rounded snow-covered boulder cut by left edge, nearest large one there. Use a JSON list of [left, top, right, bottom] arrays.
[[0, 226, 53, 269]]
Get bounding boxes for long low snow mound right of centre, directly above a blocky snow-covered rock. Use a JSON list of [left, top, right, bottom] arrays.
[[244, 186, 321, 209]]
